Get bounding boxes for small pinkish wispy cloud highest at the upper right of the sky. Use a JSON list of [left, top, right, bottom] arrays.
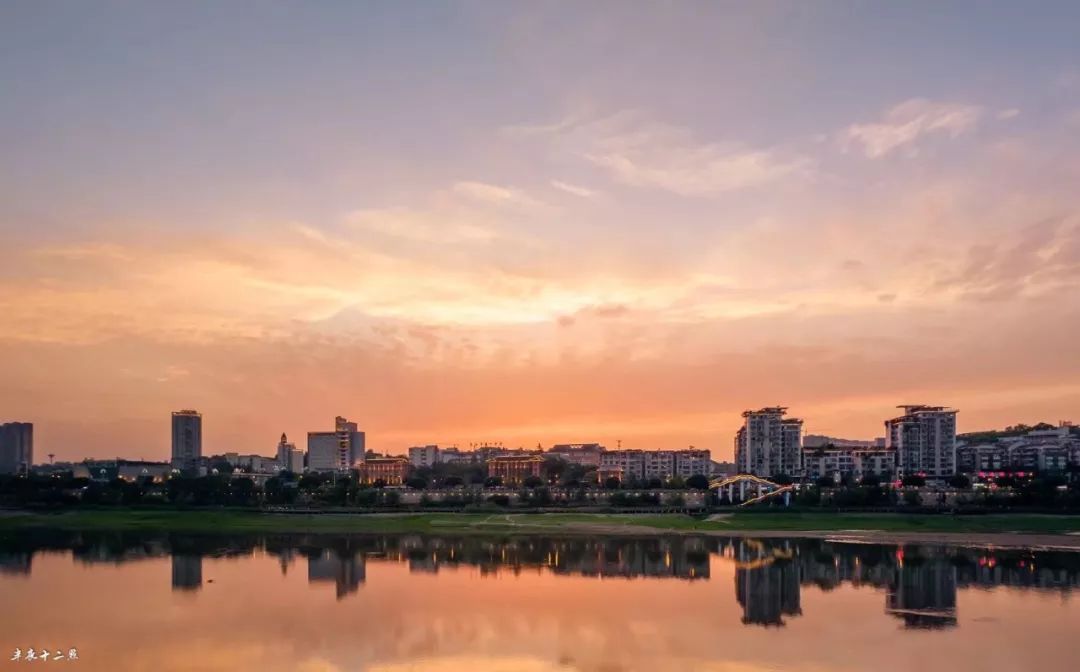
[[842, 98, 983, 159]]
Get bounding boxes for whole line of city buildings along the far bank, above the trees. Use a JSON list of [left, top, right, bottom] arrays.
[[8, 405, 1080, 485]]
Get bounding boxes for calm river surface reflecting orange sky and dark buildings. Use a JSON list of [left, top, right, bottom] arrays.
[[0, 532, 1080, 672]]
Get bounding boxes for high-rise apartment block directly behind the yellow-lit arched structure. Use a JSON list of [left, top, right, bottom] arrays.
[[735, 406, 802, 479]]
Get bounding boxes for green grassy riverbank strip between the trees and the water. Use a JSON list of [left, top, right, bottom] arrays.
[[0, 510, 1080, 535]]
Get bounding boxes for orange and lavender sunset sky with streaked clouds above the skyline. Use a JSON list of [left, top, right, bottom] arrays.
[[0, 0, 1080, 461]]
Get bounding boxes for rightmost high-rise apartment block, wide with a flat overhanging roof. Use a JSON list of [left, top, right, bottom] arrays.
[[885, 405, 957, 479]]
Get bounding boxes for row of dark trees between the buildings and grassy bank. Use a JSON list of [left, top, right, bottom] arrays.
[[8, 470, 1080, 508]]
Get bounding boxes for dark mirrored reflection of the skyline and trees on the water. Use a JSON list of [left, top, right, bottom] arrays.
[[0, 530, 1080, 628]]
